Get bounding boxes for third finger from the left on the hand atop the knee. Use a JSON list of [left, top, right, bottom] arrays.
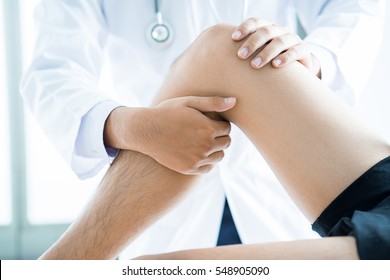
[[251, 34, 307, 69]]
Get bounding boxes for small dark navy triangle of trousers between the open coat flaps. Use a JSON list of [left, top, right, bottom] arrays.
[[217, 199, 241, 246]]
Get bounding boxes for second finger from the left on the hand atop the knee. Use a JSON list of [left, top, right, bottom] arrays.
[[237, 26, 297, 59]]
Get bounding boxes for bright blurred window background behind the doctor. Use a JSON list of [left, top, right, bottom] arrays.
[[0, 0, 390, 259]]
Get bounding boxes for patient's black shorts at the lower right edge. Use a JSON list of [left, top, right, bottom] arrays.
[[313, 154, 390, 259]]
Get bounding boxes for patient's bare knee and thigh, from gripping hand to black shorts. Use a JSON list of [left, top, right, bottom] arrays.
[[155, 25, 390, 222]]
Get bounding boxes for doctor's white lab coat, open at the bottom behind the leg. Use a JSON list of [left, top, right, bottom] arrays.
[[21, 0, 384, 258]]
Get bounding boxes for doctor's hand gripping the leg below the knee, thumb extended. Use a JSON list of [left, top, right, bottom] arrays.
[[105, 96, 236, 175]]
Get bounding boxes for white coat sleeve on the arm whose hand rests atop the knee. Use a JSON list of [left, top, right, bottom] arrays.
[[295, 0, 385, 105]]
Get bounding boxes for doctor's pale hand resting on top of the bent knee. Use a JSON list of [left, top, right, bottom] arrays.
[[232, 18, 321, 77]]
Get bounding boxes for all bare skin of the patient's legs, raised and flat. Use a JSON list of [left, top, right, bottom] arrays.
[[42, 25, 390, 259]]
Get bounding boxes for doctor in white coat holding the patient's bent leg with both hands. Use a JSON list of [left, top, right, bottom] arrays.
[[21, 0, 384, 258]]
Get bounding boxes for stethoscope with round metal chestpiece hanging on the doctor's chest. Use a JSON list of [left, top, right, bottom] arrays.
[[146, 0, 248, 48]]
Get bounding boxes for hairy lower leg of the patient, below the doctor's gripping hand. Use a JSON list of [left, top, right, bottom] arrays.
[[41, 151, 196, 259]]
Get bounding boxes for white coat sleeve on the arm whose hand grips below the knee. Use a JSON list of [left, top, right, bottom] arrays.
[[20, 0, 119, 178]]
